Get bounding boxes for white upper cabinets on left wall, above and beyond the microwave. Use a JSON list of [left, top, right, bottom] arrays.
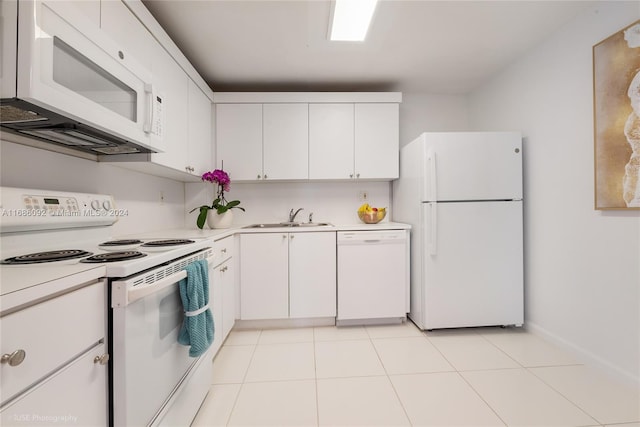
[[97, 0, 215, 181]]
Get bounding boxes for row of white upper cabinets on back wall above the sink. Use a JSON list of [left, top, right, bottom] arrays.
[[218, 92, 402, 181]]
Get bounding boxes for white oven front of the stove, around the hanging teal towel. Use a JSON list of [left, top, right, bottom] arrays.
[[110, 249, 213, 426]]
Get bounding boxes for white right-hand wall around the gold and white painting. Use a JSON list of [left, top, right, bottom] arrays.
[[469, 2, 640, 381]]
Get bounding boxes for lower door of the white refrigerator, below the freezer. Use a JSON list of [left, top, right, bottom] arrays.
[[422, 201, 524, 329]]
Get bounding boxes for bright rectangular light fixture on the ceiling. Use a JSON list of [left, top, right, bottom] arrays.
[[329, 0, 378, 41]]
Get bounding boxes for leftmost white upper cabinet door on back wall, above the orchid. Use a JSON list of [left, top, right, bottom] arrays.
[[215, 104, 262, 181]]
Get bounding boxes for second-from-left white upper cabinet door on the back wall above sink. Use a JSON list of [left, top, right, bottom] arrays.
[[262, 104, 309, 179]]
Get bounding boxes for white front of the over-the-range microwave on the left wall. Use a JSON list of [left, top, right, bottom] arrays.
[[14, 0, 163, 152]]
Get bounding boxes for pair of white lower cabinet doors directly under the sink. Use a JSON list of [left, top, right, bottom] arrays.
[[240, 232, 336, 320]]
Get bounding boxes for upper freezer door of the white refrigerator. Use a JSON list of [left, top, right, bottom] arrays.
[[421, 132, 522, 202]]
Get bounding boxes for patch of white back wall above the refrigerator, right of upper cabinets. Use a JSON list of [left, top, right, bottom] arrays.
[[400, 92, 468, 147]]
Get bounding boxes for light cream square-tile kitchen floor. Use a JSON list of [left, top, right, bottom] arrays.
[[193, 322, 640, 427]]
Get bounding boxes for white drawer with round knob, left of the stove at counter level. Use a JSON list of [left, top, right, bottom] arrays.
[[0, 282, 106, 402]]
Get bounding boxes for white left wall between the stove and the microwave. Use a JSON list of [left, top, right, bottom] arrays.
[[0, 141, 184, 236]]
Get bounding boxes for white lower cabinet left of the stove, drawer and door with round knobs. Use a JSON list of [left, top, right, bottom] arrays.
[[0, 282, 108, 426]]
